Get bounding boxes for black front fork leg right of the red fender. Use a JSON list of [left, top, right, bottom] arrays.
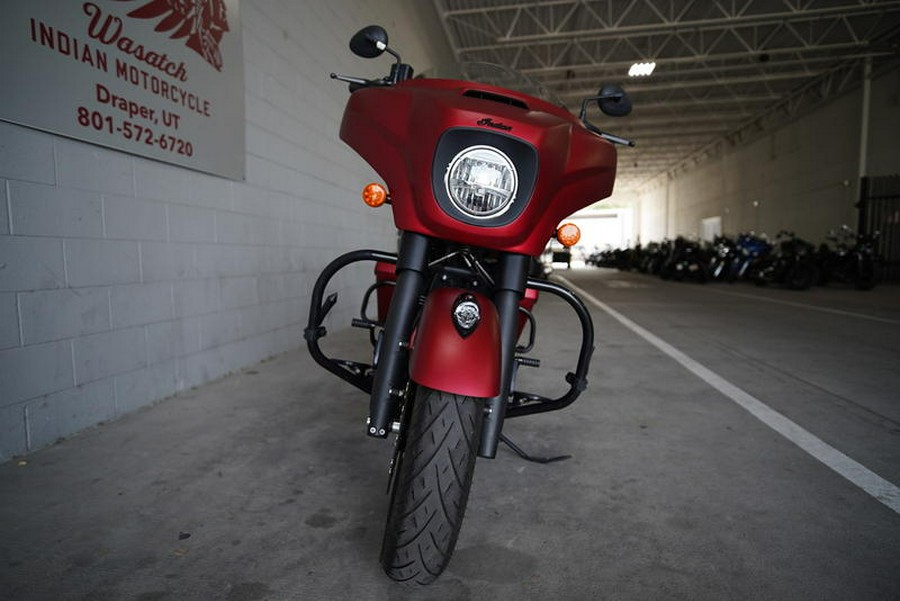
[[478, 254, 531, 458]]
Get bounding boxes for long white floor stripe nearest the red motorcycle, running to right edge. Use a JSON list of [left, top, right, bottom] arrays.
[[559, 276, 900, 513]]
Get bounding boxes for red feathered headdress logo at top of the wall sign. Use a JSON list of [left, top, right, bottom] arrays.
[[119, 0, 229, 71]]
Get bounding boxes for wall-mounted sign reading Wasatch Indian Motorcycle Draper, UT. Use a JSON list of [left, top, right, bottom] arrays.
[[0, 0, 244, 179]]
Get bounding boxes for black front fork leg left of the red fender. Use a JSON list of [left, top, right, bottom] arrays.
[[366, 232, 428, 438]]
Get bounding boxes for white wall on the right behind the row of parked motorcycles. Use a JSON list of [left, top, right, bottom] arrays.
[[638, 63, 900, 243]]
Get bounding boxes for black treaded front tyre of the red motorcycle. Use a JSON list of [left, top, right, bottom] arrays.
[[381, 387, 484, 584]]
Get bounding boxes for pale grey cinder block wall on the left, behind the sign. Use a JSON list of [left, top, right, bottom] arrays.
[[0, 0, 449, 461]]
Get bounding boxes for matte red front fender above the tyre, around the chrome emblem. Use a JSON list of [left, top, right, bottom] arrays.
[[409, 288, 500, 398]]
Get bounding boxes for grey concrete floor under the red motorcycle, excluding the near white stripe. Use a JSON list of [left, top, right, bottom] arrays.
[[0, 269, 900, 601]]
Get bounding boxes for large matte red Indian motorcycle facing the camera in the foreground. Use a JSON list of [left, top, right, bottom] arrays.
[[304, 25, 631, 584]]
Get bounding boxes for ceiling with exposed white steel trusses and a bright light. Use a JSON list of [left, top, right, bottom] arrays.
[[434, 0, 900, 189]]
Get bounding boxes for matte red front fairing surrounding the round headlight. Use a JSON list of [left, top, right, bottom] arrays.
[[341, 79, 616, 256]]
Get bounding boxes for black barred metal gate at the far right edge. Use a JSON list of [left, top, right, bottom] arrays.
[[857, 175, 900, 282]]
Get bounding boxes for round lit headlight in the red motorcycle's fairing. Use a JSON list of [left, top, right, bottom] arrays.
[[444, 146, 519, 219]]
